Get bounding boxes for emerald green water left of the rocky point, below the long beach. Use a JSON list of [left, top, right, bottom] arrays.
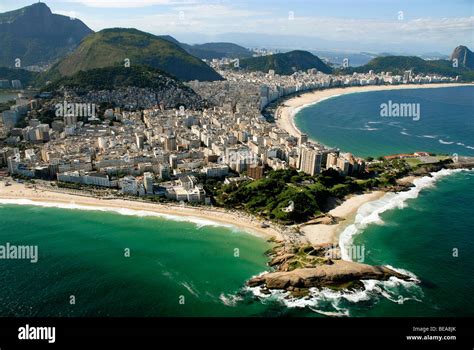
[[0, 205, 270, 317]]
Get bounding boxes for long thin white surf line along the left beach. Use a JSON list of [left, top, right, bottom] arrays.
[[0, 199, 242, 232]]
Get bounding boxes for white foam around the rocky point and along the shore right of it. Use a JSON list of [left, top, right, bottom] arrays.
[[246, 169, 467, 317]]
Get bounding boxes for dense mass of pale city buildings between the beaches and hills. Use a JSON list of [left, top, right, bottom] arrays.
[[0, 66, 460, 202]]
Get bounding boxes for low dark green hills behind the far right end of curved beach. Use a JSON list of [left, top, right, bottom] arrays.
[[343, 56, 474, 80]]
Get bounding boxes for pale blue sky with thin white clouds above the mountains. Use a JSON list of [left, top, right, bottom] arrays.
[[0, 0, 474, 54]]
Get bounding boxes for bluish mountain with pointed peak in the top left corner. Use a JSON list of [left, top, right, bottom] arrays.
[[0, 3, 92, 67]]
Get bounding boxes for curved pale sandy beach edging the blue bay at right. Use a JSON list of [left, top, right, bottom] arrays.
[[275, 83, 473, 137]]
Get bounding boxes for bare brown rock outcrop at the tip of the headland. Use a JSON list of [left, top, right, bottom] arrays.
[[247, 260, 410, 290]]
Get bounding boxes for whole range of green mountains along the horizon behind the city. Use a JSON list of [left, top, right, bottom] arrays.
[[0, 3, 474, 85]]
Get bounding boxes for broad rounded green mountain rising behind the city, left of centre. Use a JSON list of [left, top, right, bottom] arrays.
[[48, 28, 222, 81]]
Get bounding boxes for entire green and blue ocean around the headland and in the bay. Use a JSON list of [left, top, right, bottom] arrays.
[[0, 87, 474, 317]]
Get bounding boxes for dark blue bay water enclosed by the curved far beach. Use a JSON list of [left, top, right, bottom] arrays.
[[295, 86, 474, 157]]
